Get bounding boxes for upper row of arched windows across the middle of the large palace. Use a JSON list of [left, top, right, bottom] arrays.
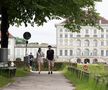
[[59, 39, 108, 47]]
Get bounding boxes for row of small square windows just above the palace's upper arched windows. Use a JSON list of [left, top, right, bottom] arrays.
[[60, 34, 108, 38]]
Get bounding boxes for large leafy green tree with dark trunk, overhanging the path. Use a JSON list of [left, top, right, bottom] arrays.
[[0, 0, 100, 48]]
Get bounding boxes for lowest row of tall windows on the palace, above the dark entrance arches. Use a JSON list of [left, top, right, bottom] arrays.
[[59, 49, 108, 56]]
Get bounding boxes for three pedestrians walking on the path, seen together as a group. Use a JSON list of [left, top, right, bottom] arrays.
[[29, 45, 54, 74]]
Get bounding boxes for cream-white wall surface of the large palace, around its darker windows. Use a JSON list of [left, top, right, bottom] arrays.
[[56, 24, 108, 62]]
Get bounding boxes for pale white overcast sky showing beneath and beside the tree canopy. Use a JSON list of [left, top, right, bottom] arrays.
[[9, 0, 108, 44]]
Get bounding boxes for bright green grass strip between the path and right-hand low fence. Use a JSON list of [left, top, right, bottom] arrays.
[[63, 68, 107, 90]]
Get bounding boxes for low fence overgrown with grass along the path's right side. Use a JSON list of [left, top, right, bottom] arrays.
[[68, 66, 108, 90]]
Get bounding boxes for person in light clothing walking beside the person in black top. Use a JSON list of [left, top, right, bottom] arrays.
[[36, 48, 44, 74]]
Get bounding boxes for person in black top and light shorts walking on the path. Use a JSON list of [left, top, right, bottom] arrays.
[[46, 45, 54, 74]]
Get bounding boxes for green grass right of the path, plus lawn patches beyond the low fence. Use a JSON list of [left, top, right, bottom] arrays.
[[63, 65, 108, 90]]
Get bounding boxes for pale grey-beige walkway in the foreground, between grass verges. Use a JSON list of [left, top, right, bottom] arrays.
[[2, 71, 74, 90]]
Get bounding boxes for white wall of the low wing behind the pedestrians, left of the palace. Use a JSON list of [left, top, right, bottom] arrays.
[[15, 44, 56, 61]]
